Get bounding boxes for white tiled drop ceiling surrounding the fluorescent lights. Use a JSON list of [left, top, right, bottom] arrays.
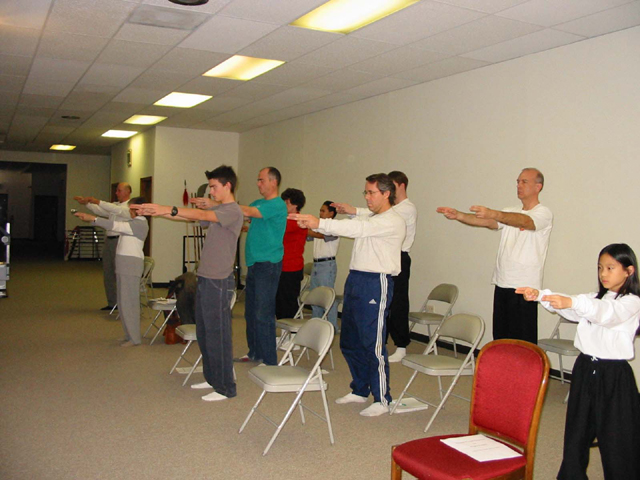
[[0, 0, 640, 153]]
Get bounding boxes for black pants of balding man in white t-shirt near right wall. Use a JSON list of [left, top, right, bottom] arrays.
[[493, 286, 538, 344]]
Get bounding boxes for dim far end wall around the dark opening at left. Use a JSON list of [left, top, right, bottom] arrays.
[[0, 150, 111, 230]]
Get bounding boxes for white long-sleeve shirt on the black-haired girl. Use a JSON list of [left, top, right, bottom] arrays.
[[538, 290, 640, 360]]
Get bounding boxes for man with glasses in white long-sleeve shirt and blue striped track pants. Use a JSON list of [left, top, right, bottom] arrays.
[[289, 173, 406, 417]]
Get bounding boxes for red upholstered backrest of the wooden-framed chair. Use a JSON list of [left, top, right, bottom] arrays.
[[469, 339, 549, 478]]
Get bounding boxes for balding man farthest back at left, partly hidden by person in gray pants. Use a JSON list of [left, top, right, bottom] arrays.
[[74, 182, 131, 310]]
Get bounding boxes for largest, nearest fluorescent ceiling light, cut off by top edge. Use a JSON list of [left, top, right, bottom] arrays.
[[291, 0, 420, 33]]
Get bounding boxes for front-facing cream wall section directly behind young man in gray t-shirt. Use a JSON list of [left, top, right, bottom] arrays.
[[151, 127, 239, 282]]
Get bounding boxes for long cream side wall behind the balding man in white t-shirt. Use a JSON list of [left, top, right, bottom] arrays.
[[240, 28, 640, 378]]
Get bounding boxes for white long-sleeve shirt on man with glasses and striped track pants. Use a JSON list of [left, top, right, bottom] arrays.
[[316, 208, 406, 275]]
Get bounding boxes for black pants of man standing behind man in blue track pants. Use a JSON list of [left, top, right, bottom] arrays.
[[386, 252, 411, 348]]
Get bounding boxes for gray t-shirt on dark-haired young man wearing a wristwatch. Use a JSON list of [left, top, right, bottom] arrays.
[[198, 202, 244, 280]]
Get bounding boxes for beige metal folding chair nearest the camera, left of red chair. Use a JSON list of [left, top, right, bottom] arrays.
[[238, 318, 334, 455]]
